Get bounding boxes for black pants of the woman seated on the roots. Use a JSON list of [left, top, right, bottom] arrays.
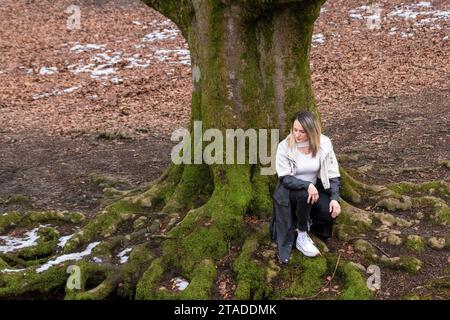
[[289, 179, 335, 239]]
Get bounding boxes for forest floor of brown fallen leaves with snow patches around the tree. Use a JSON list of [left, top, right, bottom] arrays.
[[0, 0, 450, 299]]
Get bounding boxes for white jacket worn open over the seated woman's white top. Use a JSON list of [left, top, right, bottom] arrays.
[[275, 134, 340, 189]]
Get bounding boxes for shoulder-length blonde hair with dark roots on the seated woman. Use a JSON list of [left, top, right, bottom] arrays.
[[287, 111, 321, 157]]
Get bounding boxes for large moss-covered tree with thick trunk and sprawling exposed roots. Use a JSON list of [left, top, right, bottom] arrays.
[[0, 0, 450, 299]]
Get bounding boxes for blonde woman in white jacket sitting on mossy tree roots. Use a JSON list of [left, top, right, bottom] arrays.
[[271, 111, 341, 264]]
